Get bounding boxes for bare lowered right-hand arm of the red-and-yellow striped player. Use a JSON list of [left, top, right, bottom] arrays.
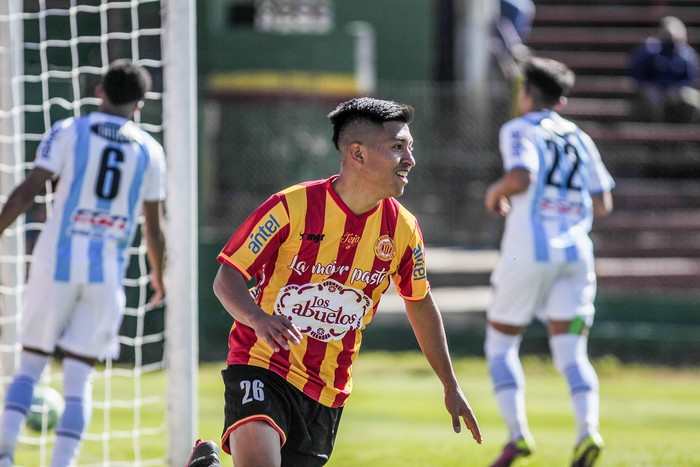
[[404, 292, 482, 444]]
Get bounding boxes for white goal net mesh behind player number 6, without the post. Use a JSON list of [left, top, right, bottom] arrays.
[[0, 0, 166, 466]]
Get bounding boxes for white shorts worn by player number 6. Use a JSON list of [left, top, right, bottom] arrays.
[[20, 272, 126, 360]]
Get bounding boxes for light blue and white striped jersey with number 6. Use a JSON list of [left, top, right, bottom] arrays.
[[32, 112, 165, 283]]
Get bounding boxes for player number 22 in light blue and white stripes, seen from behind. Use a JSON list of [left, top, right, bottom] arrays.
[[484, 57, 614, 466]]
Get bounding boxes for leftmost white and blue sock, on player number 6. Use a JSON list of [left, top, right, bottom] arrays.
[[0, 350, 49, 458]]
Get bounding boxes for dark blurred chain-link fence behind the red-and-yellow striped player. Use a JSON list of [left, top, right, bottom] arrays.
[[201, 82, 511, 248]]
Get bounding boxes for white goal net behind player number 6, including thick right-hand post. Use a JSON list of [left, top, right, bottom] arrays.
[[0, 0, 197, 467]]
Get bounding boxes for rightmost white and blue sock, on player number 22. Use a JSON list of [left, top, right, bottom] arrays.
[[549, 334, 600, 443]]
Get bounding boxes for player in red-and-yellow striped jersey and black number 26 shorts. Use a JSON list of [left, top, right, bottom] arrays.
[[191, 97, 481, 467]]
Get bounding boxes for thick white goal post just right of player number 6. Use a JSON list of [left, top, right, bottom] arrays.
[[163, 0, 199, 465]]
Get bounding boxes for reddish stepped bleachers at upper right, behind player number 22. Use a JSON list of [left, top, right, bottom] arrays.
[[528, 0, 700, 294]]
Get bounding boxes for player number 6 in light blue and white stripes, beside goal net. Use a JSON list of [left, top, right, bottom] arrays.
[[0, 60, 165, 467]]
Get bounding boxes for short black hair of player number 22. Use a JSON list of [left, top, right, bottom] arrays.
[[523, 57, 576, 108]]
